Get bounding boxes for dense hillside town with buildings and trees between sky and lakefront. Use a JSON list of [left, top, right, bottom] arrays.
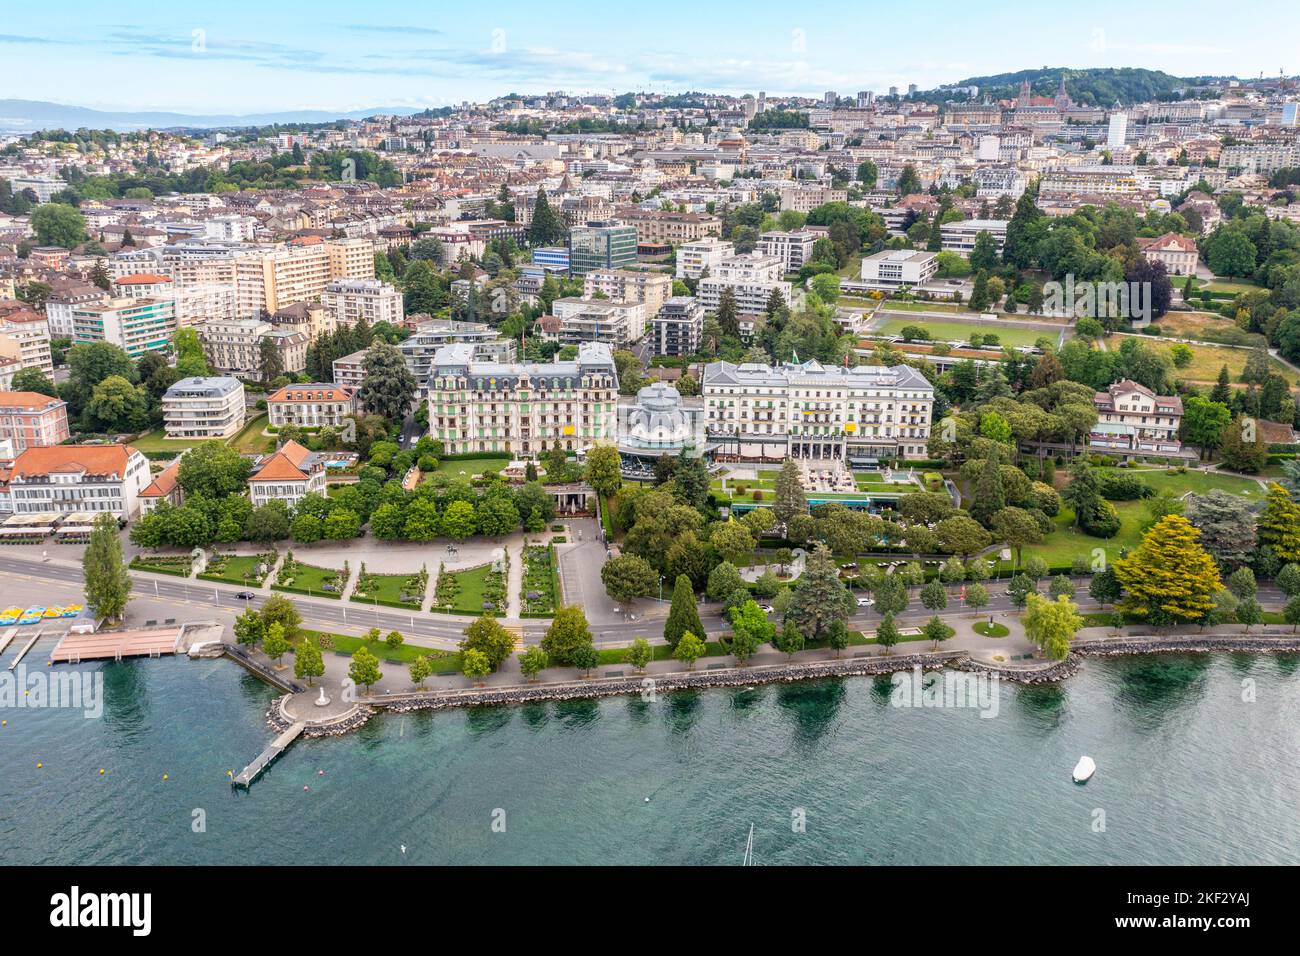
[[0, 69, 1300, 707]]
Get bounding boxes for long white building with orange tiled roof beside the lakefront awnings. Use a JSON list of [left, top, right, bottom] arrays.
[[9, 445, 151, 522]]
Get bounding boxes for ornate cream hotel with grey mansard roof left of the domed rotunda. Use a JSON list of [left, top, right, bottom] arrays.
[[429, 342, 619, 458]]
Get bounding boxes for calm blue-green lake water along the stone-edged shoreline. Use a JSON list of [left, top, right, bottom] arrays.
[[0, 654, 1300, 865]]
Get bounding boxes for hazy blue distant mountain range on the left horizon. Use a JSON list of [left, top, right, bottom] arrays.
[[0, 99, 423, 133]]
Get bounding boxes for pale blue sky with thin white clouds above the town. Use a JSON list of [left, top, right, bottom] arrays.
[[0, 0, 1300, 113]]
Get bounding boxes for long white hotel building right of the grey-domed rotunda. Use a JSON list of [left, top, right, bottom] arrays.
[[701, 362, 935, 460]]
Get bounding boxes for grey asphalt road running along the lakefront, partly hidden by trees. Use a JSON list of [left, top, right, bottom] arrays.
[[0, 550, 1286, 649]]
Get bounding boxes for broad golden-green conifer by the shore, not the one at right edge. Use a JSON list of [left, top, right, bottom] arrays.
[[1113, 515, 1223, 626]]
